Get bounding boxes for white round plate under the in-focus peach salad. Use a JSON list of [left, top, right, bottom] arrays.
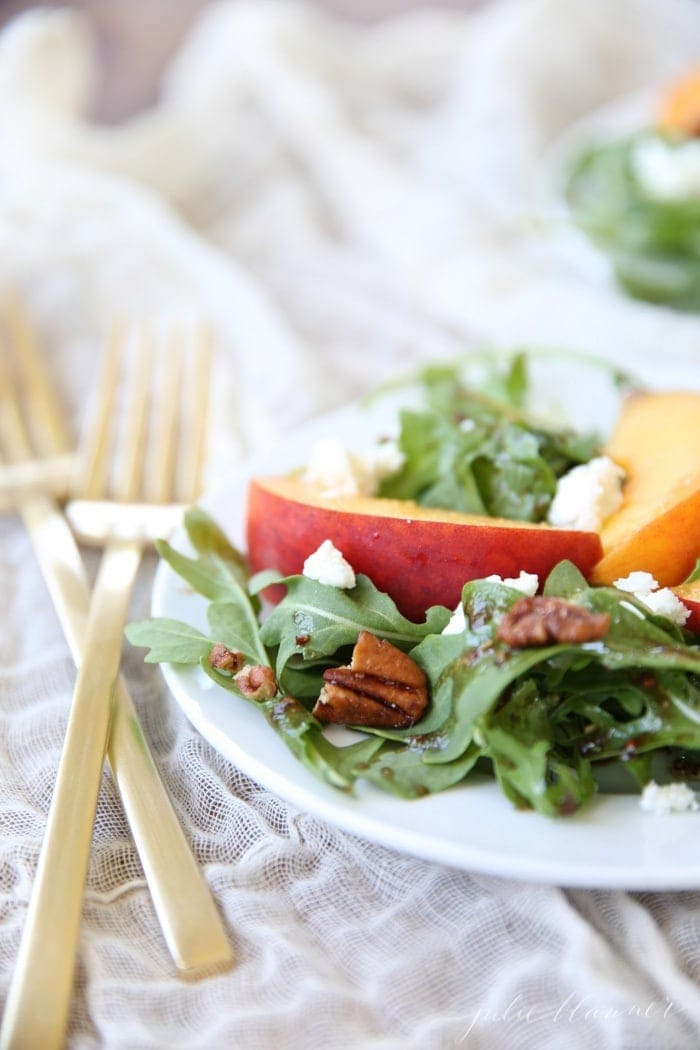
[[152, 356, 700, 889]]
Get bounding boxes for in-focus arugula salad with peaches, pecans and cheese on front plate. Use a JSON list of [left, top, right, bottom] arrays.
[[127, 355, 700, 816]]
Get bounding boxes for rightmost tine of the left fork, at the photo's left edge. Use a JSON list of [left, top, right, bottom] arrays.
[[1, 292, 72, 455]]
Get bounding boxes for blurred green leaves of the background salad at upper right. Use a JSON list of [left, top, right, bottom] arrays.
[[565, 131, 700, 311]]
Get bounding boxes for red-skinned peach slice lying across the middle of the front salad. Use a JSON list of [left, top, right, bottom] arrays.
[[247, 477, 602, 621]]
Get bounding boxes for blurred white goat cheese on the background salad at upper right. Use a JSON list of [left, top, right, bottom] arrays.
[[632, 137, 700, 201]]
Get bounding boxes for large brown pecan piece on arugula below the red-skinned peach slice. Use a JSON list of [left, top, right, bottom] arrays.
[[313, 631, 428, 729]]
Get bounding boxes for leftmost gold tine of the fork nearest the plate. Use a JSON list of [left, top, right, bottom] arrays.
[[75, 321, 125, 499]]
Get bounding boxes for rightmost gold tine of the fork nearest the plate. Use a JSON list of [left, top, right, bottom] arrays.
[[178, 324, 212, 503]]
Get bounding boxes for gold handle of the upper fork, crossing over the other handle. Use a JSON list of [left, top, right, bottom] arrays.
[[3, 544, 142, 1050]]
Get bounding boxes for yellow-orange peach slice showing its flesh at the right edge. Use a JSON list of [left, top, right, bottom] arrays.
[[592, 392, 700, 587]]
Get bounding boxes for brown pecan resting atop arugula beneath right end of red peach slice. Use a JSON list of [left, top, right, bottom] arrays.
[[497, 594, 610, 649]]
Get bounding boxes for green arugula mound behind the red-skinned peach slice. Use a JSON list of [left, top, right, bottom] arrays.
[[377, 354, 599, 522]]
